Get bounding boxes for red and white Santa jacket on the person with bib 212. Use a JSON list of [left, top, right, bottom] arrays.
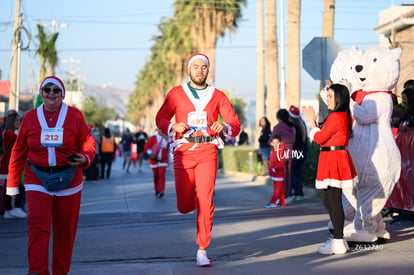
[[7, 103, 96, 196]]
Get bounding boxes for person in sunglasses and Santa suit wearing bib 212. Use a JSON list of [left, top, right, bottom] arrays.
[[7, 76, 95, 275]]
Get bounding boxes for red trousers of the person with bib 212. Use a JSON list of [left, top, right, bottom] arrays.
[[26, 191, 81, 275]]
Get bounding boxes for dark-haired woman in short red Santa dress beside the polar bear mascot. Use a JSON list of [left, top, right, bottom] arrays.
[[303, 84, 358, 254]]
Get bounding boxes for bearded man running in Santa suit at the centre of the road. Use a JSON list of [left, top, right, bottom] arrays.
[[156, 54, 240, 266]]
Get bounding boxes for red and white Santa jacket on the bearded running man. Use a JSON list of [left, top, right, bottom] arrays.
[[155, 83, 240, 150]]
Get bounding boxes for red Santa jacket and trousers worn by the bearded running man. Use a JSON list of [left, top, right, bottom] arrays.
[[156, 83, 240, 248]]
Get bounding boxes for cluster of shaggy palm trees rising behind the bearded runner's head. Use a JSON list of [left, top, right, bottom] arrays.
[[127, 0, 246, 130]]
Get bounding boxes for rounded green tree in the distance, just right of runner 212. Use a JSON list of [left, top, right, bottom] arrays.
[[82, 97, 118, 130]]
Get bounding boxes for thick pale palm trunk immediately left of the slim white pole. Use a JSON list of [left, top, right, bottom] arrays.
[[265, 0, 280, 125]]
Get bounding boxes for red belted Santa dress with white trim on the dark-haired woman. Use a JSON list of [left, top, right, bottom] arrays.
[[310, 112, 358, 189]]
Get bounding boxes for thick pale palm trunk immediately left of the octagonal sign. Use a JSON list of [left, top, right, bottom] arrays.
[[286, 0, 301, 107]]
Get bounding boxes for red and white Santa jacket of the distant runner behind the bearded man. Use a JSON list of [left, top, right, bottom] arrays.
[[144, 134, 170, 168]]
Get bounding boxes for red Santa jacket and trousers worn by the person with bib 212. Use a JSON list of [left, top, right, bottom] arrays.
[[7, 103, 95, 275]]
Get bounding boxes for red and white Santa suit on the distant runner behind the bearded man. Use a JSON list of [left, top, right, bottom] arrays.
[[144, 134, 169, 193]]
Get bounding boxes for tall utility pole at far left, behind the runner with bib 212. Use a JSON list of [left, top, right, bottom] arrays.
[[8, 0, 22, 111]]
